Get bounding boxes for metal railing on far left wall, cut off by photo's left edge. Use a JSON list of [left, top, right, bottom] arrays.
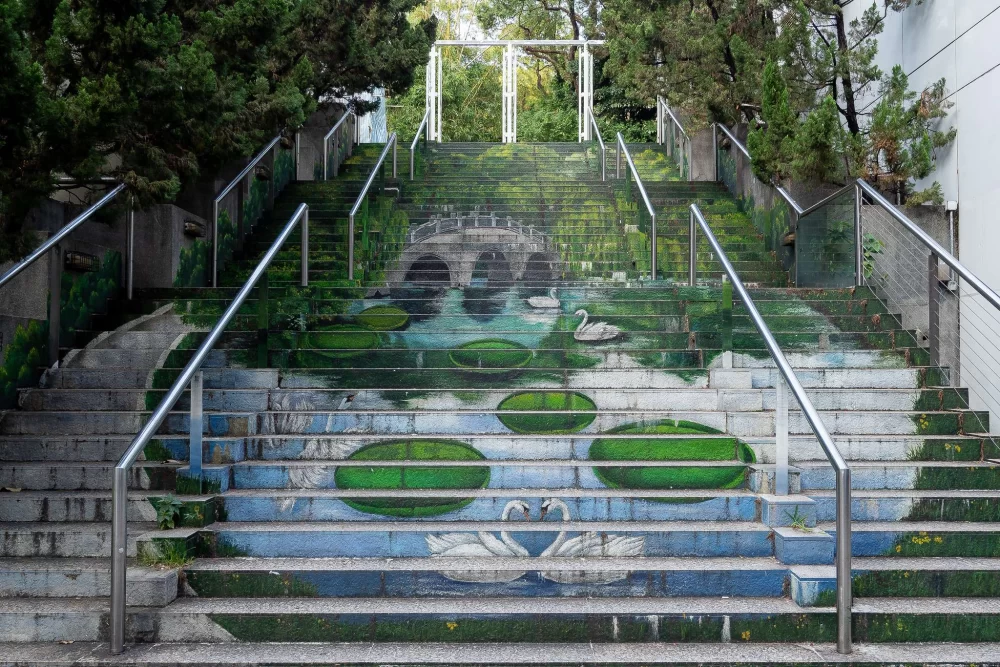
[[0, 183, 127, 366]]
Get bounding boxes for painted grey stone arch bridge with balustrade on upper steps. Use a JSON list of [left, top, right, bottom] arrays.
[[386, 212, 560, 287]]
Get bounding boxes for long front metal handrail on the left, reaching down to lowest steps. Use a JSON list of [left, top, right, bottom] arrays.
[[111, 204, 309, 654]]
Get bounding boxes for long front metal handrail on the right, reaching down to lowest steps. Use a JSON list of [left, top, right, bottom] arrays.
[[688, 204, 852, 653]]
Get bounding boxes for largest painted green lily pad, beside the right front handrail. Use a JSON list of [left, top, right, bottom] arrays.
[[589, 420, 755, 490]]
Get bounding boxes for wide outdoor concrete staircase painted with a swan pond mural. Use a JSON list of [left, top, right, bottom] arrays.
[[0, 144, 1000, 665]]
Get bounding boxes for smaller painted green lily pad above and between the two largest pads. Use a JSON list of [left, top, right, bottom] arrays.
[[497, 391, 597, 434]]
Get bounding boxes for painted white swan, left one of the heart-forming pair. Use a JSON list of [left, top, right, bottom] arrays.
[[426, 500, 531, 583]]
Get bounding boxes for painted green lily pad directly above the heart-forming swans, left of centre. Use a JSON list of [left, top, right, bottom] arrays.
[[334, 440, 490, 517]]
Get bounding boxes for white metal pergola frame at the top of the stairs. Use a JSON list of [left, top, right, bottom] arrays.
[[426, 39, 604, 144]]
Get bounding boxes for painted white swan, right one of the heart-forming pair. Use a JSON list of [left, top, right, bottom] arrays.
[[539, 498, 646, 584]]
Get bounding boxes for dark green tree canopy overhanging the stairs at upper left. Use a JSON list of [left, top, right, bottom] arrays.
[[0, 0, 435, 254]]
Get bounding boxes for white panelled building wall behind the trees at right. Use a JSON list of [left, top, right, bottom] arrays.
[[844, 0, 1000, 431]]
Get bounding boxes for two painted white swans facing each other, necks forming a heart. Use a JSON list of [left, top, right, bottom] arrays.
[[426, 498, 646, 584]]
